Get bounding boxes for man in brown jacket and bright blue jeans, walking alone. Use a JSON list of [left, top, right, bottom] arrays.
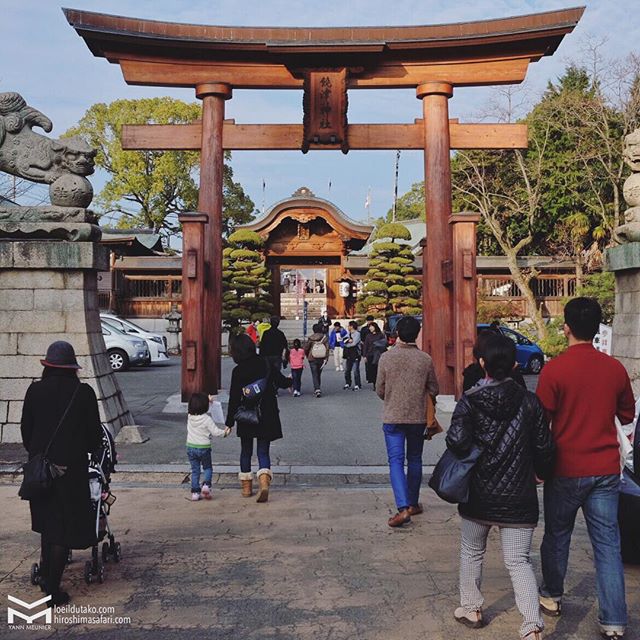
[[376, 316, 438, 527]]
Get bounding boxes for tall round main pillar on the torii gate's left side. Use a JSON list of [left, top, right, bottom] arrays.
[[196, 82, 231, 394]]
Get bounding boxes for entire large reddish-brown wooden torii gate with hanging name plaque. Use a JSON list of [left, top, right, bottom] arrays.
[[64, 7, 584, 398]]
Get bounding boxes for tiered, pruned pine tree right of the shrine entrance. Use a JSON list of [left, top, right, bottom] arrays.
[[359, 222, 422, 315]]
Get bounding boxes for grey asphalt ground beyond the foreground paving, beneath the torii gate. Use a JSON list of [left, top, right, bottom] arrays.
[[0, 357, 537, 466]]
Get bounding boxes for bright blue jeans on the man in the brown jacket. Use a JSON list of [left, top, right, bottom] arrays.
[[382, 423, 425, 510]]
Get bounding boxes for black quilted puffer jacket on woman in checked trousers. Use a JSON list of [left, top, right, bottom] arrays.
[[447, 378, 555, 526]]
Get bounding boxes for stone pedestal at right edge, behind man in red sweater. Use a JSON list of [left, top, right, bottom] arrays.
[[606, 242, 640, 396]]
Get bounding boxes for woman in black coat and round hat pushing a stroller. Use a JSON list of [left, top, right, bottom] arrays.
[[21, 341, 102, 605]]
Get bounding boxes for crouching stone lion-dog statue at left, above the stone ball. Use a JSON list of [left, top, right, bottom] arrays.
[[0, 92, 96, 184]]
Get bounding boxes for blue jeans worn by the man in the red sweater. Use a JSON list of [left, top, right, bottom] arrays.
[[540, 475, 627, 627]]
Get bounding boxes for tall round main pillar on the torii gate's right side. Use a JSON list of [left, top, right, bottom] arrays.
[[416, 82, 455, 395]]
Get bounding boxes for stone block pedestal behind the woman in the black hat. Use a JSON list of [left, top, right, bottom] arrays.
[[0, 239, 133, 442]]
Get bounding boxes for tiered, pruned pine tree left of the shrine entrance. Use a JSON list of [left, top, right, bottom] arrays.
[[222, 229, 273, 334]]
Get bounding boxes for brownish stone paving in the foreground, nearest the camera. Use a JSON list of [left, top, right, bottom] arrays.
[[0, 485, 640, 640]]
